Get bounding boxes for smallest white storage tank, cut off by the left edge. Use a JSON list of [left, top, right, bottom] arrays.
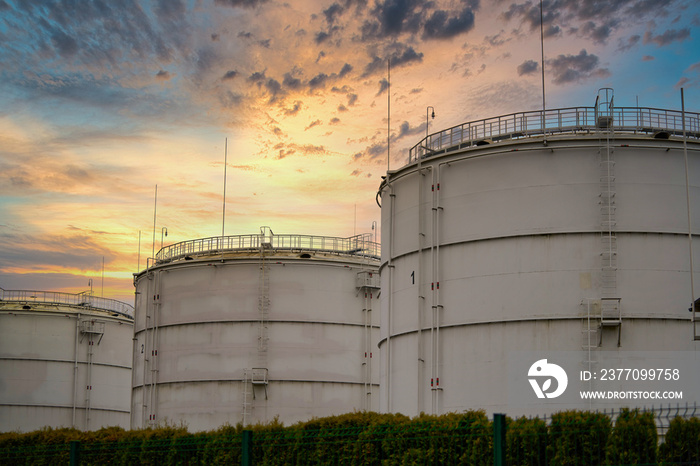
[[0, 290, 134, 432]]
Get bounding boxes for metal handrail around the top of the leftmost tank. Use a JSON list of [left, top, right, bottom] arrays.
[[0, 288, 134, 320]]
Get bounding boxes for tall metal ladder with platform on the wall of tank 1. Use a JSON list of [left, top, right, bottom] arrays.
[[595, 88, 622, 346]]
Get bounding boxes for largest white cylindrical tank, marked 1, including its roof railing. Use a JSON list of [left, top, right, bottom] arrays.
[[379, 90, 700, 416]]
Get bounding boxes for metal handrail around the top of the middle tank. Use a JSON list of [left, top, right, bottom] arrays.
[[155, 233, 381, 264]]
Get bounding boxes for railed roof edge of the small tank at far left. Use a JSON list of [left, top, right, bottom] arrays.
[[0, 288, 134, 320]]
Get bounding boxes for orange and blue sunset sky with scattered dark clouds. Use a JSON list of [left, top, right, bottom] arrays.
[[0, 0, 700, 304]]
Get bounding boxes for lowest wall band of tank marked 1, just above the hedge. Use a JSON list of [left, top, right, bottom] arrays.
[[382, 319, 697, 417]]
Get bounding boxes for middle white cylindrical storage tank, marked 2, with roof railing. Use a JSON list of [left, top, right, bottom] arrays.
[[131, 228, 379, 431]]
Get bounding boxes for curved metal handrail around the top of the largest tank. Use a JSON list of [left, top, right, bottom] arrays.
[[408, 107, 700, 163]]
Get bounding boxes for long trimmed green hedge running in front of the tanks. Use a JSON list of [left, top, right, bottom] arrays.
[[0, 410, 700, 466]]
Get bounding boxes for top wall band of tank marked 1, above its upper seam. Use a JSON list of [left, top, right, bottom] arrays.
[[382, 139, 700, 261]]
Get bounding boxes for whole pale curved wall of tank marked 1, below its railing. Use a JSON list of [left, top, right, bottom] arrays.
[[380, 137, 700, 415]]
